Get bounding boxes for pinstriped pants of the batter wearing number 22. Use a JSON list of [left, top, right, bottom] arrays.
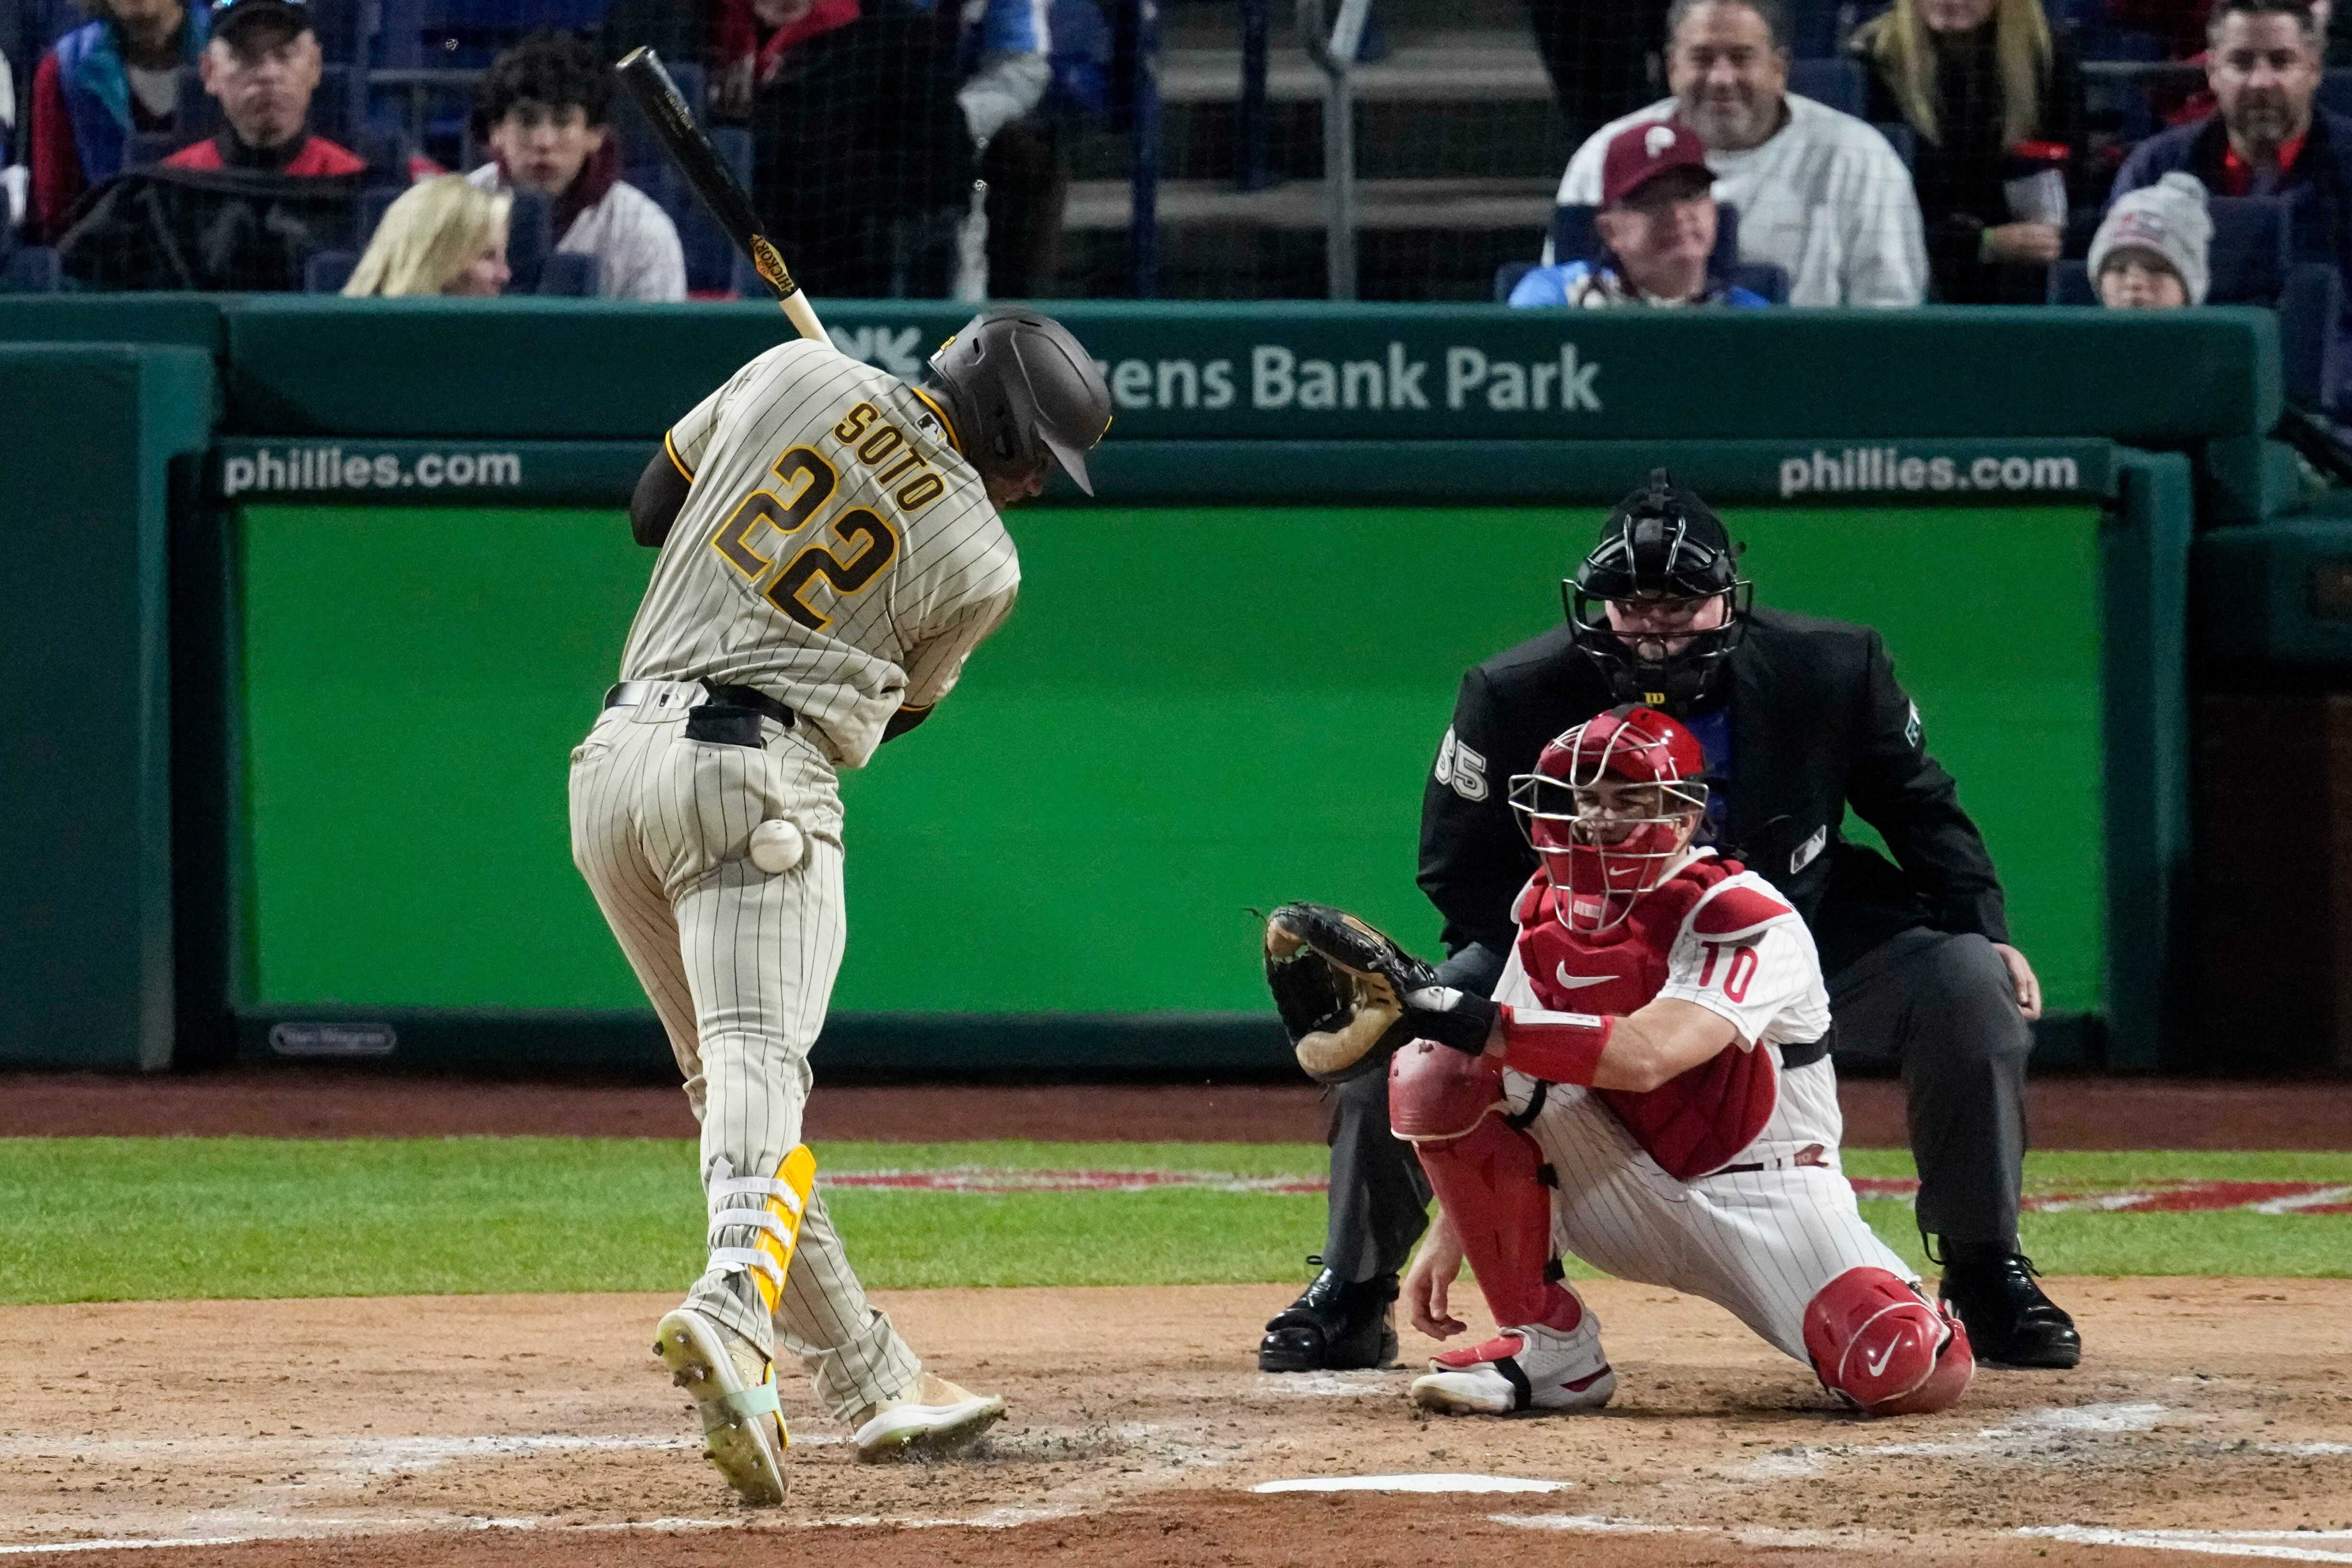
[[571, 682, 922, 1420]]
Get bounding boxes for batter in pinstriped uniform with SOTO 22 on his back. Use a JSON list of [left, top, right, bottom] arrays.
[[571, 310, 1110, 1502]]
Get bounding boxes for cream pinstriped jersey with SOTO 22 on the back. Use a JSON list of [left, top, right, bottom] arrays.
[[621, 338, 1021, 769]]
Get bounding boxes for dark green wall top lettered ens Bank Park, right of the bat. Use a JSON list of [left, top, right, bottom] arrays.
[[809, 301, 2263, 451]]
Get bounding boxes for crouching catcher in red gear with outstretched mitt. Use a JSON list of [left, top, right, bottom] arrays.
[[1265, 705, 1976, 1415]]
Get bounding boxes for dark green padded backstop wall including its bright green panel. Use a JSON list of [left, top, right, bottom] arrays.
[[0, 299, 2248, 1072]]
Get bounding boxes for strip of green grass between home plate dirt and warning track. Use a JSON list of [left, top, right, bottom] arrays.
[[0, 1138, 2352, 1302]]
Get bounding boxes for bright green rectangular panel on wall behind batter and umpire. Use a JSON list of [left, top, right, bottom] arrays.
[[238, 505, 2105, 1013]]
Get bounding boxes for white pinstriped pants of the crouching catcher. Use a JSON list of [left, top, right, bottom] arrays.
[[1503, 1062, 1919, 1361]]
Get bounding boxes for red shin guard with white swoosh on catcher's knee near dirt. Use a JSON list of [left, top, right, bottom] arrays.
[[1804, 1269, 1976, 1415]]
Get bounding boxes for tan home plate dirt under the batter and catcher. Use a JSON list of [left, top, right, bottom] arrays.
[[0, 1279, 2352, 1568]]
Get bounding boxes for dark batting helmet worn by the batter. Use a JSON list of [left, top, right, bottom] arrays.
[[931, 306, 1110, 496]]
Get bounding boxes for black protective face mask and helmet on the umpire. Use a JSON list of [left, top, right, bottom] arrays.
[[1560, 468, 1755, 717]]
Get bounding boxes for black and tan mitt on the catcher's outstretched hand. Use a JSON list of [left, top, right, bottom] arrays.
[[1265, 903, 1437, 1084]]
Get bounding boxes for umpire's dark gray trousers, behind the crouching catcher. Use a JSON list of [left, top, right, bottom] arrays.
[[1322, 926, 2035, 1281]]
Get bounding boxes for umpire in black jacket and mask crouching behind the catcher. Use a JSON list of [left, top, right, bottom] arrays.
[[1258, 470, 2082, 1371]]
